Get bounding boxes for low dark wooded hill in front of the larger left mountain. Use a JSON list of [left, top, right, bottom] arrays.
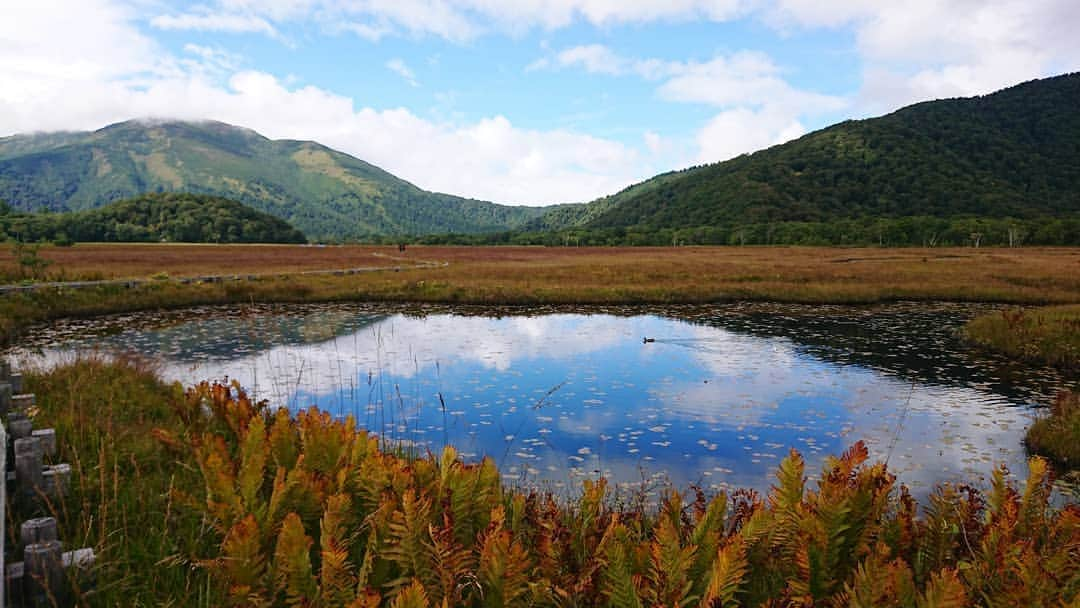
[[0, 192, 307, 243]]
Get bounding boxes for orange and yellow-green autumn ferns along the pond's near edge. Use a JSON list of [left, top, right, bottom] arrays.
[[158, 383, 1080, 608]]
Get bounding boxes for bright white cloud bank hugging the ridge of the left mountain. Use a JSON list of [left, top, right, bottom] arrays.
[[0, 0, 656, 204]]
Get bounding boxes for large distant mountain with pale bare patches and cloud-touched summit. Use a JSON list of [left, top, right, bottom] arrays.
[[0, 120, 543, 240]]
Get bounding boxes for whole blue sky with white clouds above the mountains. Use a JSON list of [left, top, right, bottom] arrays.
[[0, 0, 1080, 205]]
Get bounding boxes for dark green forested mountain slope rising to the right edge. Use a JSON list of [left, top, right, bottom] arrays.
[[525, 73, 1080, 230]]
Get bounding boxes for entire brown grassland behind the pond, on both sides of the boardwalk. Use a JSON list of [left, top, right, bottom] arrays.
[[0, 244, 1080, 347]]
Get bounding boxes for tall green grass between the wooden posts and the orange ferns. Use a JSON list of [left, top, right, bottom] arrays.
[[20, 356, 217, 606]]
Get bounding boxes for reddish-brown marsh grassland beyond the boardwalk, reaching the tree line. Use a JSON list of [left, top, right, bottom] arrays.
[[6, 244, 1080, 303]]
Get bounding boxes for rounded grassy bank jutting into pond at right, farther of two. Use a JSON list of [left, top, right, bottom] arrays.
[[963, 305, 1080, 373]]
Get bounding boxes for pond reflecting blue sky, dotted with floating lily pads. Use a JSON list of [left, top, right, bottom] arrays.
[[13, 303, 1066, 495]]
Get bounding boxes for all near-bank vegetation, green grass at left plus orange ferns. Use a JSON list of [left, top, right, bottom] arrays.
[[21, 360, 1080, 608]]
